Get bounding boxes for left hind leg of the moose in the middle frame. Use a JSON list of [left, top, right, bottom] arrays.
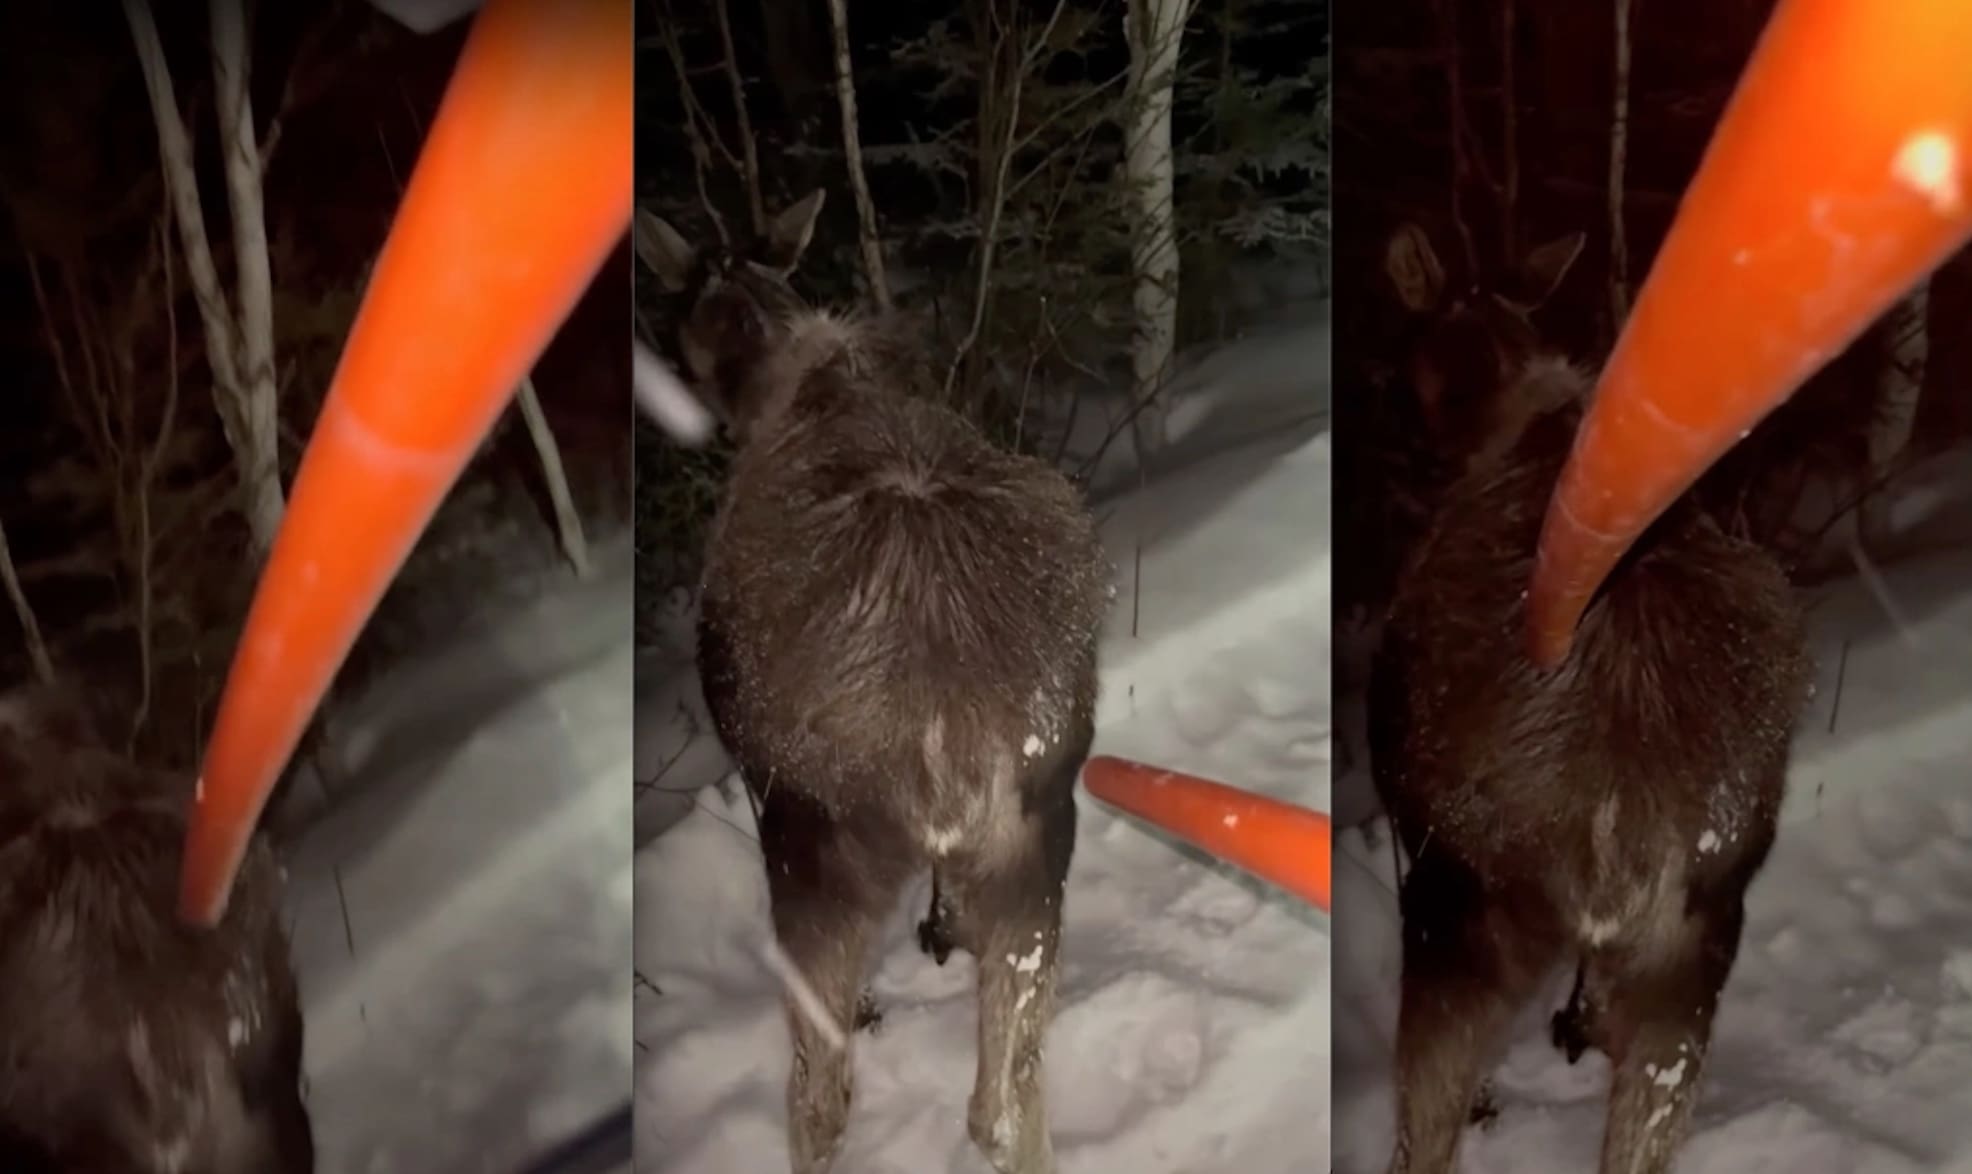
[[759, 781, 911, 1174]]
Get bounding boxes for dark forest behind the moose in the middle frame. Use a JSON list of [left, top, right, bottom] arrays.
[[637, 0, 1329, 639]]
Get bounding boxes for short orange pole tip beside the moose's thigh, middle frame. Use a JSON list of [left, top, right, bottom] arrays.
[[1083, 754, 1333, 912]]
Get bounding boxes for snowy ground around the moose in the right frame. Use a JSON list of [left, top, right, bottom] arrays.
[[1335, 462, 1972, 1174]]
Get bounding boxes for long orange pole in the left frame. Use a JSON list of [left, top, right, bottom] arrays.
[[179, 0, 633, 925]]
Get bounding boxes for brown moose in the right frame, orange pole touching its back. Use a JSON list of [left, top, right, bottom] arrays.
[[1369, 222, 1812, 1174]]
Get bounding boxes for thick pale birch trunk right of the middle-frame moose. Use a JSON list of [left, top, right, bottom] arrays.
[[1124, 0, 1193, 460]]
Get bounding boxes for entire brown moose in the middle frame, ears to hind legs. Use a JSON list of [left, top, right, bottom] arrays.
[[639, 191, 1110, 1174]]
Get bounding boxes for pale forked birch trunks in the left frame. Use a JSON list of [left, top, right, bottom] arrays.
[[122, 0, 286, 558]]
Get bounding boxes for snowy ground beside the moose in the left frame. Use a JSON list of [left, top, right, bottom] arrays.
[[288, 539, 633, 1174]]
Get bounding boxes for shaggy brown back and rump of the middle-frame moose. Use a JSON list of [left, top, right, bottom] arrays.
[[704, 335, 1108, 836]]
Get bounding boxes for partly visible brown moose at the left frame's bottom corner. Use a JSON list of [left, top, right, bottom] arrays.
[[0, 691, 314, 1174]]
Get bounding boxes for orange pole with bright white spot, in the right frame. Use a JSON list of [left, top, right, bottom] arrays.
[[1528, 0, 1972, 667]]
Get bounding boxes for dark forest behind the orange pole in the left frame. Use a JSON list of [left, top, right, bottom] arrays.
[[0, 0, 631, 789]]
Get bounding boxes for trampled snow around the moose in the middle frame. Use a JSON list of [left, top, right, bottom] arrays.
[[637, 310, 1329, 1174]]
